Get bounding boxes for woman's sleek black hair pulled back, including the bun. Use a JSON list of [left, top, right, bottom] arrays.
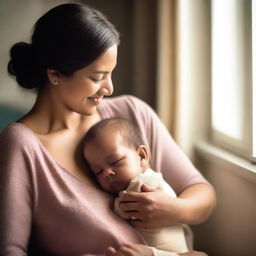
[[8, 3, 119, 90]]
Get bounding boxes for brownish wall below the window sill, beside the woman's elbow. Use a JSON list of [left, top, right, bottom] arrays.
[[193, 148, 256, 256]]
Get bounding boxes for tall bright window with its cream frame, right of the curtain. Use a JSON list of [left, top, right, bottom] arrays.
[[211, 0, 256, 159]]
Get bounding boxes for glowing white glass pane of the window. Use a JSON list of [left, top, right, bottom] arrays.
[[212, 0, 244, 140]]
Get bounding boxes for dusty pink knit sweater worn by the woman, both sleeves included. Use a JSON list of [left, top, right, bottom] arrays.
[[0, 96, 207, 256]]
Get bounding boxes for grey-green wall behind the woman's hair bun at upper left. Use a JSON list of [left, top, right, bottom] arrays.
[[0, 0, 72, 110]]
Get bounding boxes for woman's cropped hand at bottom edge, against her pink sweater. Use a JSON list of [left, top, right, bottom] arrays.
[[106, 244, 153, 256]]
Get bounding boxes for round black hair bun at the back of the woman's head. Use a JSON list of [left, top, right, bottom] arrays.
[[8, 42, 40, 89]]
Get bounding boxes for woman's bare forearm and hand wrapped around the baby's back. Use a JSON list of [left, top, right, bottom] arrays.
[[119, 184, 215, 228]]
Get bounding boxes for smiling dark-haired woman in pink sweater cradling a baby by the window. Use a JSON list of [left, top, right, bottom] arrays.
[[0, 4, 215, 256]]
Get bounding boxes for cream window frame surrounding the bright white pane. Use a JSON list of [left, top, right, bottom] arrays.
[[210, 0, 256, 162]]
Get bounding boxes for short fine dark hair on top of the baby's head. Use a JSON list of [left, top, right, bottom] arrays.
[[84, 117, 143, 150]]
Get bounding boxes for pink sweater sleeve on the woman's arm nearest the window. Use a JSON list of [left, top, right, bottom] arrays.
[[119, 96, 208, 195]]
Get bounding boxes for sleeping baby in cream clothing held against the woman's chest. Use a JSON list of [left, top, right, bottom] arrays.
[[83, 118, 188, 253]]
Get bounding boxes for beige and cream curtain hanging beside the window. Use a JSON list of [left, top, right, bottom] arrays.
[[157, 0, 211, 157]]
